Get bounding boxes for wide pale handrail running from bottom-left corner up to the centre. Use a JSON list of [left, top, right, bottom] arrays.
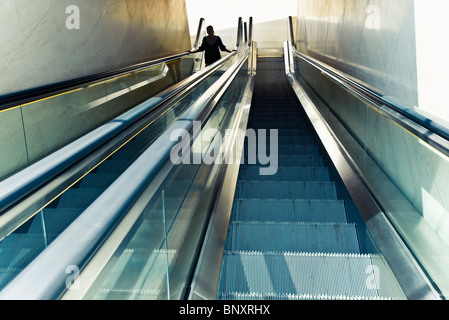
[[0, 18, 248, 300]]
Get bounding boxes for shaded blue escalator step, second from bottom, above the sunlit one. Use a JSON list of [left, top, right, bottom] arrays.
[[227, 222, 360, 253]]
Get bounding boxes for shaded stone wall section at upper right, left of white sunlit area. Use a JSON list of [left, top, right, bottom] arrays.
[[296, 0, 418, 106]]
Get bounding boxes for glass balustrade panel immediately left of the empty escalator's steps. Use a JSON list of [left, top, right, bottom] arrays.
[[84, 58, 248, 300]]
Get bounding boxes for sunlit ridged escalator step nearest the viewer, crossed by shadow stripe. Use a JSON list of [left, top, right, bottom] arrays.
[[219, 252, 402, 299]]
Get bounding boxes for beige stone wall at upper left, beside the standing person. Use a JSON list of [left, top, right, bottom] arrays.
[[0, 0, 190, 95]]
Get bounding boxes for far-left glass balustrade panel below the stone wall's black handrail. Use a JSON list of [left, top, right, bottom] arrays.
[[0, 53, 202, 179]]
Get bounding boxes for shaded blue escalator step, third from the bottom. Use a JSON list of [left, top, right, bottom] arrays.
[[233, 200, 348, 223]]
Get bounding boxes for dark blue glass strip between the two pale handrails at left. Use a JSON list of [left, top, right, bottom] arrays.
[[0, 58, 222, 296]]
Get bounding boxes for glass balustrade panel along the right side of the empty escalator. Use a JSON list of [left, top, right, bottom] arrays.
[[295, 58, 449, 296]]
